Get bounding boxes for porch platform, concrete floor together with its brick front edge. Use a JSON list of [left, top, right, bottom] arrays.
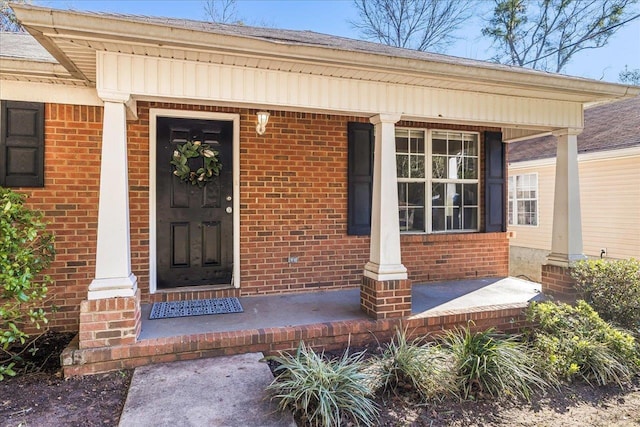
[[62, 277, 544, 376]]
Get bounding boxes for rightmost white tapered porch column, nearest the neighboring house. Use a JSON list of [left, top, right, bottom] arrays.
[[547, 129, 585, 267]]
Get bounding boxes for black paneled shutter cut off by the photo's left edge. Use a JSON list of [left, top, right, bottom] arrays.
[[0, 101, 44, 187]]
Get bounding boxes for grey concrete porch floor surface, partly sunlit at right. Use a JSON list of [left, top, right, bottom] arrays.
[[138, 277, 543, 341]]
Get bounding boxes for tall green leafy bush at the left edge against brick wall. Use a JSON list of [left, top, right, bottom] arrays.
[[0, 187, 54, 379]]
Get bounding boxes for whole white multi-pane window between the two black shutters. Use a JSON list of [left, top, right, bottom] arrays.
[[396, 128, 479, 233]]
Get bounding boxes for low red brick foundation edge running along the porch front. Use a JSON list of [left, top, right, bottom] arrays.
[[61, 304, 527, 377]]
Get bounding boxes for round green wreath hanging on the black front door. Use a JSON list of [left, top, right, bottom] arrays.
[[171, 141, 222, 187]]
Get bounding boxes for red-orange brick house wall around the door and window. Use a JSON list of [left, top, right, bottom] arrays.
[[18, 102, 508, 331]]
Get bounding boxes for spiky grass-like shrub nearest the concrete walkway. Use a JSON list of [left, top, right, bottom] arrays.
[[267, 342, 378, 427]]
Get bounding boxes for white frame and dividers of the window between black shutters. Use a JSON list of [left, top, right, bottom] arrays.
[[395, 127, 481, 234]]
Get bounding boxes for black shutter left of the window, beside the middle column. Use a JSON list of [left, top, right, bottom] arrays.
[[347, 122, 375, 236]]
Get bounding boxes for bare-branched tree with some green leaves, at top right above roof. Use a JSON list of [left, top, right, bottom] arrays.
[[482, 0, 640, 72]]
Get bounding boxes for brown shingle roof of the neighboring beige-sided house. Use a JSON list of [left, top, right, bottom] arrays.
[[507, 96, 640, 163]]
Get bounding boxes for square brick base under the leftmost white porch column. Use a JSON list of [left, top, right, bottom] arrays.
[[78, 289, 142, 349]]
